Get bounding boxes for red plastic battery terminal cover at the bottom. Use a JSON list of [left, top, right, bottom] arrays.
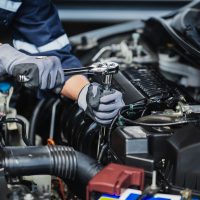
[[86, 163, 144, 200]]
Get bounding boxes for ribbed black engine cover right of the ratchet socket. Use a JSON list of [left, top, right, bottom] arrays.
[[113, 64, 180, 104]]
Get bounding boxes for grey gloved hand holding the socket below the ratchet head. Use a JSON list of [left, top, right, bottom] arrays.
[[78, 83, 125, 125]]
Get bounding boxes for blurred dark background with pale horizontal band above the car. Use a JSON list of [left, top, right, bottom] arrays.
[[53, 0, 190, 36]]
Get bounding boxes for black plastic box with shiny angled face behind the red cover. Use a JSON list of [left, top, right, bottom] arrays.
[[111, 126, 171, 172]]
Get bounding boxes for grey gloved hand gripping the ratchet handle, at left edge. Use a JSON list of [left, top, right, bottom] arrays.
[[0, 44, 64, 90]]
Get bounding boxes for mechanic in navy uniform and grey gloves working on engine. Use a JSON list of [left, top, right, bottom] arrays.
[[0, 0, 124, 124]]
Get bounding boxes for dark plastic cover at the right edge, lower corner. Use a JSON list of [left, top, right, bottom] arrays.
[[168, 125, 200, 191]]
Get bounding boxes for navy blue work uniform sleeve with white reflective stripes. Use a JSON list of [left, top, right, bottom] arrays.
[[0, 0, 81, 78]]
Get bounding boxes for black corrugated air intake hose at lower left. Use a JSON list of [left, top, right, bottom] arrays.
[[0, 146, 102, 183]]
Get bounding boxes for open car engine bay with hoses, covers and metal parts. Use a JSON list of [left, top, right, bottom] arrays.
[[0, 3, 200, 200]]
